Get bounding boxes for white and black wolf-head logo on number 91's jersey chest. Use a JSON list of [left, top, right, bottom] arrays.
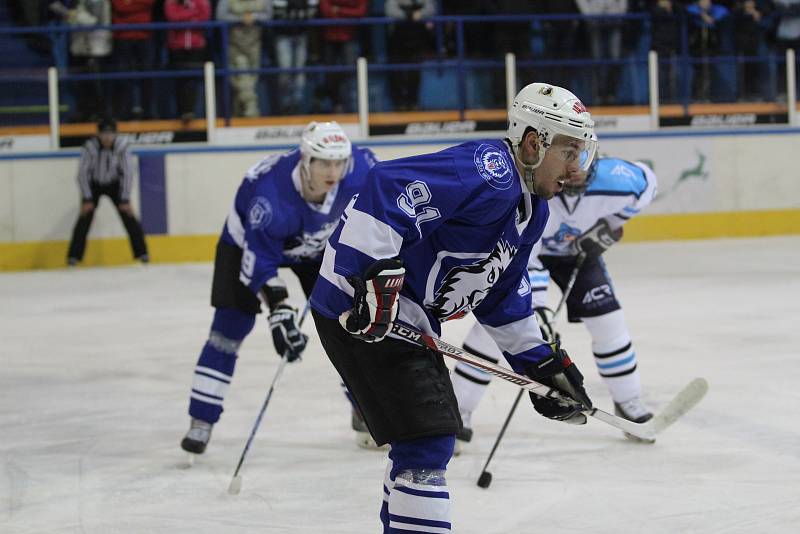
[[432, 239, 517, 322]]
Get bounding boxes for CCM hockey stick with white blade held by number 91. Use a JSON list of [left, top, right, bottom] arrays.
[[392, 322, 708, 439]]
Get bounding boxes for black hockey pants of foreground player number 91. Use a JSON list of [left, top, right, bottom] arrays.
[[311, 309, 462, 445]]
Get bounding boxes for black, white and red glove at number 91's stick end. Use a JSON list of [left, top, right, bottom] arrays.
[[339, 258, 406, 343]]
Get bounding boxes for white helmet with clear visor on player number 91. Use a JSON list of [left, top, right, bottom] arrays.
[[506, 82, 597, 170]]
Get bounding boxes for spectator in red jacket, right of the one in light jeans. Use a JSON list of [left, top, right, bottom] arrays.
[[319, 0, 368, 113]]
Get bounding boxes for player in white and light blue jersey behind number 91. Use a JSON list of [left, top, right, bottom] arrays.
[[453, 158, 657, 441]]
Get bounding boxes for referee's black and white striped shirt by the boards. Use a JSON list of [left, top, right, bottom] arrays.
[[78, 136, 133, 202]]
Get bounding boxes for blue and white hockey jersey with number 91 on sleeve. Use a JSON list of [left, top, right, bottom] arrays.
[[311, 140, 551, 372]]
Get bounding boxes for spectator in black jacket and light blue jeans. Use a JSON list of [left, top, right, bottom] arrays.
[[272, 0, 319, 114]]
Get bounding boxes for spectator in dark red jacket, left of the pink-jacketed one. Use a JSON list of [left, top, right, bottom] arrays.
[[111, 0, 155, 119]]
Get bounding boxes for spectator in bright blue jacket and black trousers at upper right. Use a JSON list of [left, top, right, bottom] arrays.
[[686, 0, 730, 101]]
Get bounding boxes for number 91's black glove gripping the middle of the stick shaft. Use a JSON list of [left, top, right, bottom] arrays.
[[527, 343, 592, 425]]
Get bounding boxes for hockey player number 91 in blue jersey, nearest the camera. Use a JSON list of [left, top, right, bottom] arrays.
[[311, 83, 596, 533]]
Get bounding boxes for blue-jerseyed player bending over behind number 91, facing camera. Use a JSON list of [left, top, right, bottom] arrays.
[[181, 122, 376, 454]]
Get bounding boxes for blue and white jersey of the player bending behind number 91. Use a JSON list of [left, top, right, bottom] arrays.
[[220, 146, 377, 292]]
